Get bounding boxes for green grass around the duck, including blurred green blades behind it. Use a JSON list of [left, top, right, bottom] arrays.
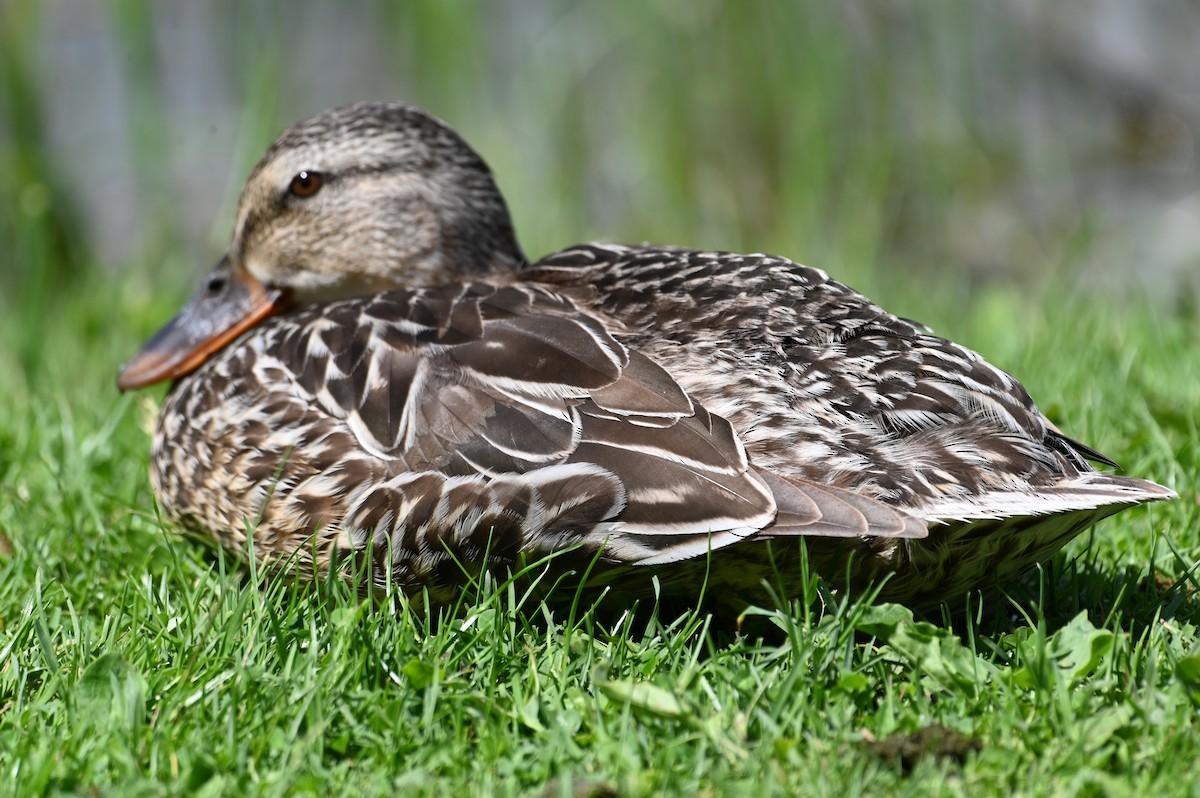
[[0, 0, 1200, 796]]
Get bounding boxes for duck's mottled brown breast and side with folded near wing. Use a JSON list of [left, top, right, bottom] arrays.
[[152, 278, 924, 598]]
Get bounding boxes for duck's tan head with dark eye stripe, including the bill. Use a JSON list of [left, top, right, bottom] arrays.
[[118, 103, 524, 390]]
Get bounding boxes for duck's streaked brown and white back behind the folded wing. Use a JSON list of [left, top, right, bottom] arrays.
[[524, 244, 1157, 518]]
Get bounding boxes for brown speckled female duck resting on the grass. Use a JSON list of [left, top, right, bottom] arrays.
[[119, 103, 1172, 605]]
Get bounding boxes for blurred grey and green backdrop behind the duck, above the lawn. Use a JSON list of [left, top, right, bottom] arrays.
[[7, 0, 1200, 316]]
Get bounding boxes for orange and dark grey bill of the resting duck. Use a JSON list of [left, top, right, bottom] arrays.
[[116, 259, 282, 391]]
